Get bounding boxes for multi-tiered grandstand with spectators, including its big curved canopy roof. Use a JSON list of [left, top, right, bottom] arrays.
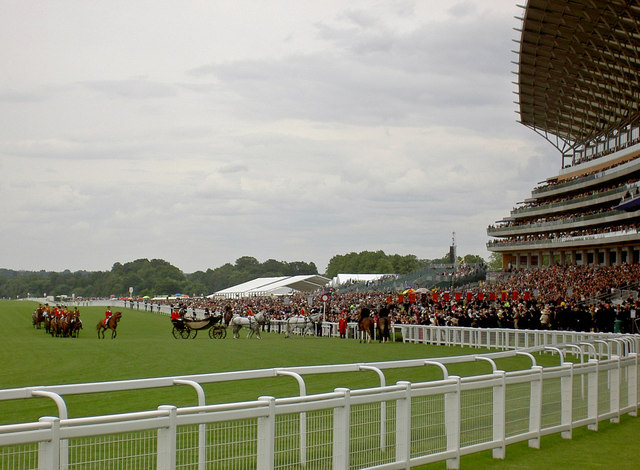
[[487, 0, 640, 269]]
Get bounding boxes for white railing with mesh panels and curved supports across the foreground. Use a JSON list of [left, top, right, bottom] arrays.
[[0, 341, 639, 470]]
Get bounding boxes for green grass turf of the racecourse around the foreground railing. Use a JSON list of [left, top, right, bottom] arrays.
[[0, 301, 640, 469]]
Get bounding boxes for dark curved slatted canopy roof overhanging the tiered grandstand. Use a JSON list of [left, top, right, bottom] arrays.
[[518, 0, 640, 152]]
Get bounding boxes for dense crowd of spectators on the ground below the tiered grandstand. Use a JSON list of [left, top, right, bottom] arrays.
[[139, 264, 640, 332]]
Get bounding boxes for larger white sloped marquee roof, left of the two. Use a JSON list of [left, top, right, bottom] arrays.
[[208, 275, 329, 297]]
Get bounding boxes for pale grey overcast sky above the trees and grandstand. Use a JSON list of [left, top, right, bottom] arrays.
[[0, 0, 561, 273]]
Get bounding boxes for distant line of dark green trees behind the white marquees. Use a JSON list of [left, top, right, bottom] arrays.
[[0, 251, 482, 298]]
